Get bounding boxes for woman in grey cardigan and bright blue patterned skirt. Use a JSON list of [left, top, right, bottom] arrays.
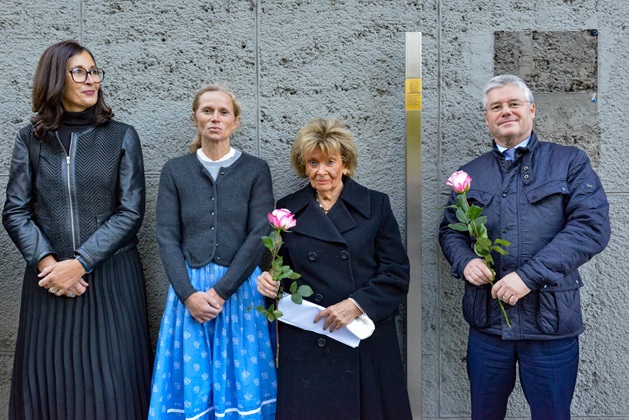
[[149, 85, 277, 419]]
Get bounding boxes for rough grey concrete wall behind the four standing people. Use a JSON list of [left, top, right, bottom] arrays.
[[0, 0, 629, 419]]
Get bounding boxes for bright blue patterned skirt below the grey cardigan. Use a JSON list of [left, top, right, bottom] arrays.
[[149, 263, 277, 420]]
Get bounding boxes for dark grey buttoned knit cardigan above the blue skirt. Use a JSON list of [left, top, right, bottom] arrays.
[[156, 152, 275, 302]]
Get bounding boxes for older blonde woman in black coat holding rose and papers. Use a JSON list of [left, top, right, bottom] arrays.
[[258, 118, 411, 420]]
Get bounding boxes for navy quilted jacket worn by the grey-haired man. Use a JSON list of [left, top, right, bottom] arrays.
[[439, 133, 610, 340]]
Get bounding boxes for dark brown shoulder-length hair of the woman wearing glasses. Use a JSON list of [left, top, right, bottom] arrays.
[[31, 40, 114, 140]]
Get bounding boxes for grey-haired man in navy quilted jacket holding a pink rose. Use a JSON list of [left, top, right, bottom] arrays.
[[439, 75, 610, 420]]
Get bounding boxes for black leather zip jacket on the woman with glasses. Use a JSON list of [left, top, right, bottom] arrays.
[[2, 121, 145, 268]]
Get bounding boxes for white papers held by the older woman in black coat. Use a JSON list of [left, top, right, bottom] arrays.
[[278, 295, 360, 348]]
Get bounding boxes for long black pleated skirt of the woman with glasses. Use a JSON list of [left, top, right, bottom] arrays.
[[9, 249, 153, 420]]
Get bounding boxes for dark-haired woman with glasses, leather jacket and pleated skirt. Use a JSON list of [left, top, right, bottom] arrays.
[[2, 41, 152, 419]]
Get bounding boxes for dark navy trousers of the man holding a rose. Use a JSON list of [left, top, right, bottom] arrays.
[[467, 328, 579, 420]]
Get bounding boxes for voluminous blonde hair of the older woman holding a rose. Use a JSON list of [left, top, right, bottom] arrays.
[[290, 118, 358, 178]]
